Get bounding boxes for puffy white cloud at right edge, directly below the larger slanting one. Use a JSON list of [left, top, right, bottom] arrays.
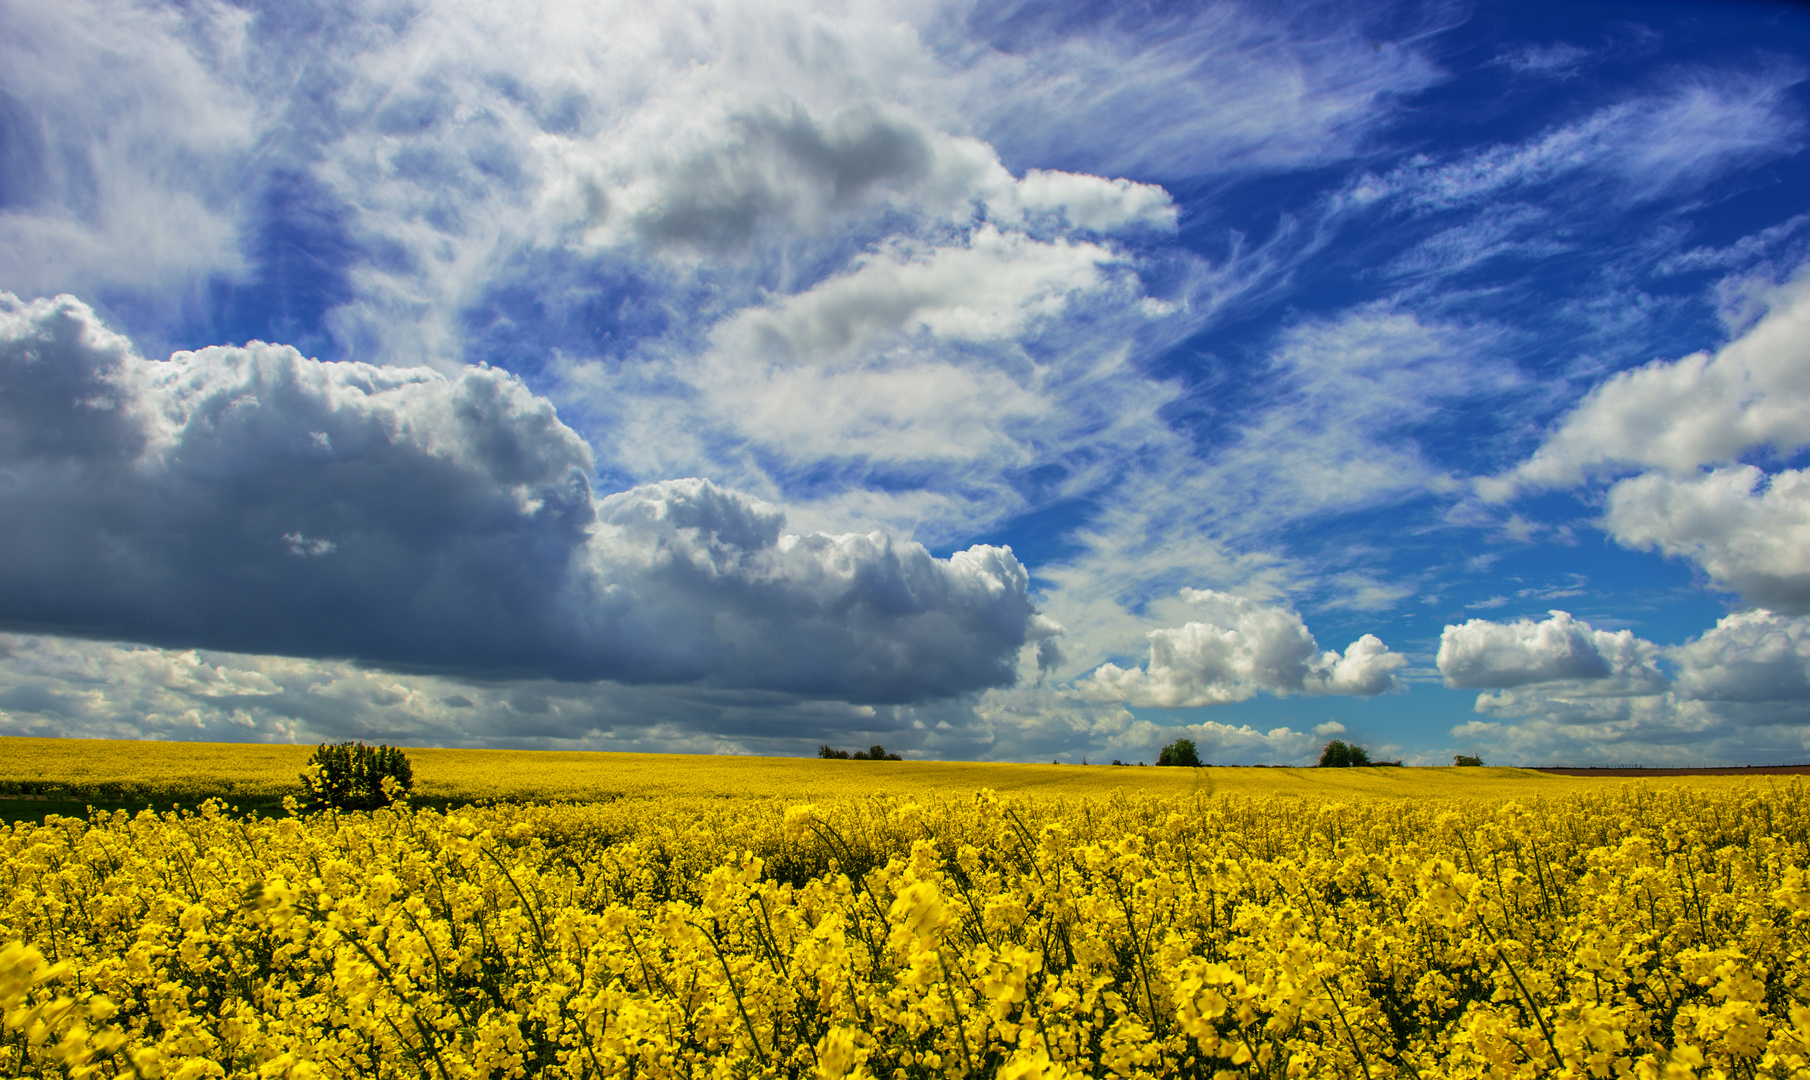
[[1604, 465, 1810, 613]]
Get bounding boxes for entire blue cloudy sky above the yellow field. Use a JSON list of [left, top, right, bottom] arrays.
[[0, 0, 1810, 765]]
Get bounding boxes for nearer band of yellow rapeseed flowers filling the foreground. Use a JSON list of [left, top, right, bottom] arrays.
[[0, 783, 1810, 1080]]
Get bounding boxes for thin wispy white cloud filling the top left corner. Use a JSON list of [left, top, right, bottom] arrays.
[[0, 0, 257, 306]]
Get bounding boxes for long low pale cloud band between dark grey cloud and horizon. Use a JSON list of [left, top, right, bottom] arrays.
[[0, 635, 1323, 763]]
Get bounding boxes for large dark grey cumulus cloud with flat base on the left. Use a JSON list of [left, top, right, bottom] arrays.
[[0, 293, 1044, 704]]
